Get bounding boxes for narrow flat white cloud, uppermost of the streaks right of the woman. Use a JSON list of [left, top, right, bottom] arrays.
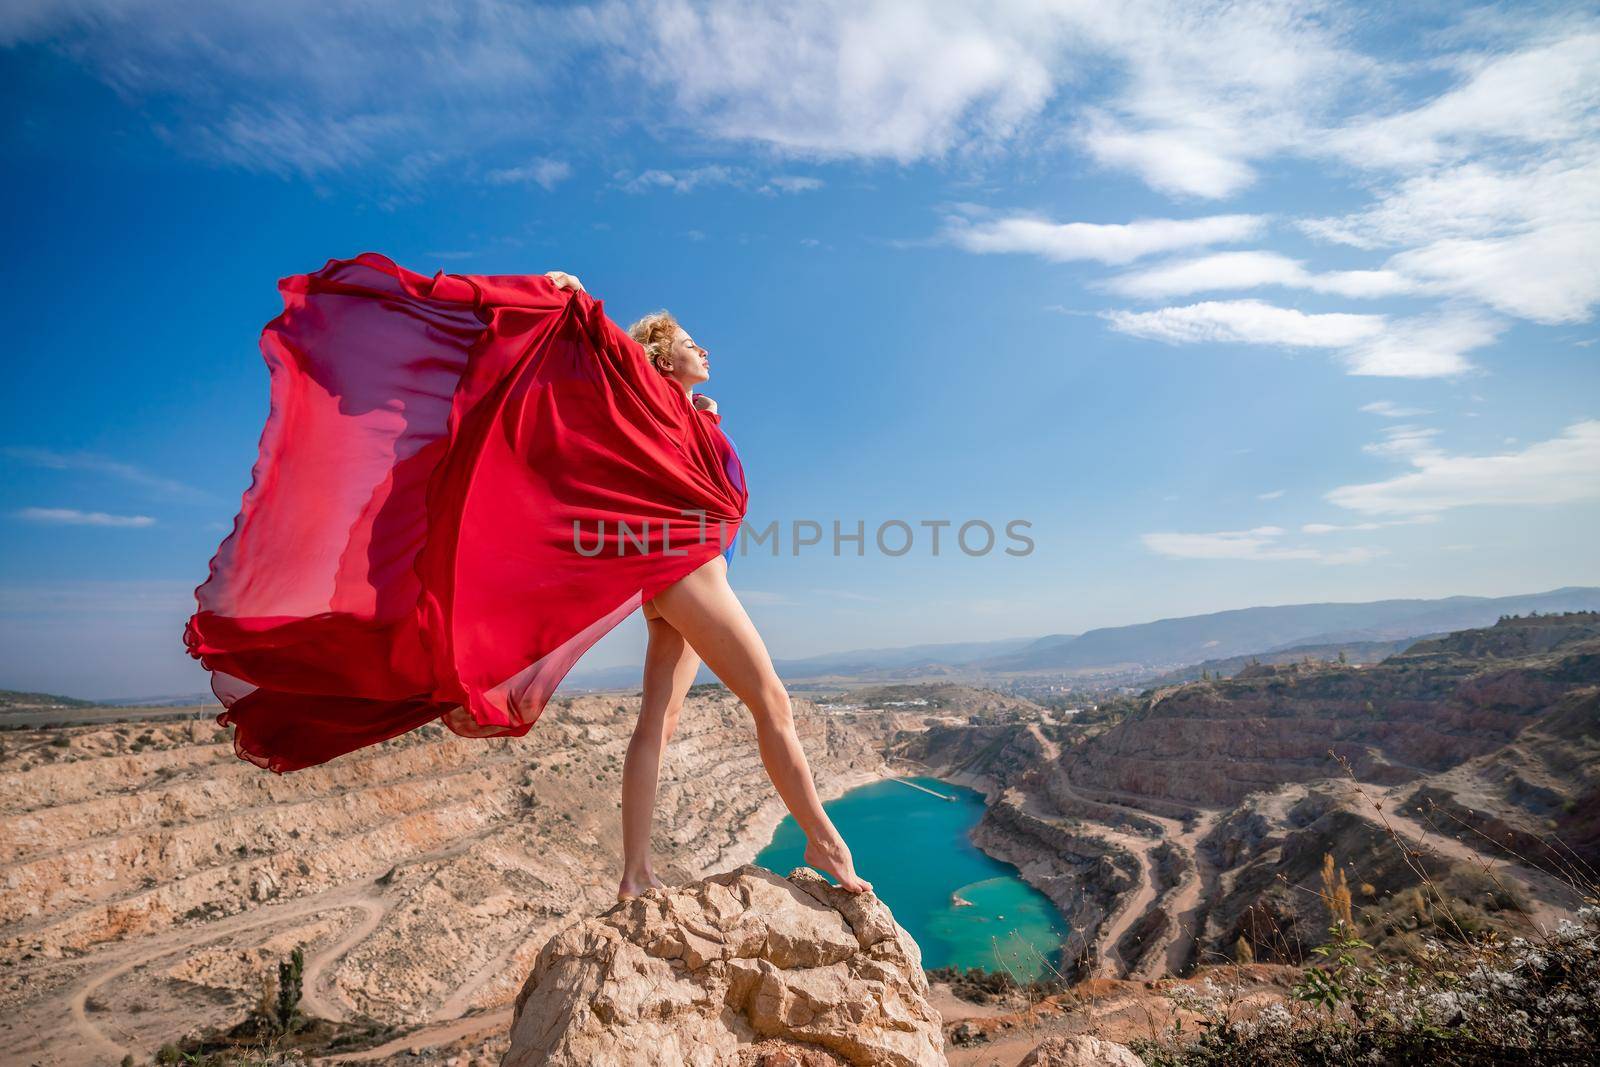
[[944, 214, 1266, 264]]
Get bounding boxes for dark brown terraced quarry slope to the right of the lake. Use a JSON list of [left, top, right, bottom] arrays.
[[896, 614, 1600, 977]]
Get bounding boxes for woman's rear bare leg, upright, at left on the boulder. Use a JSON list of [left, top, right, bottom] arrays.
[[616, 613, 699, 901]]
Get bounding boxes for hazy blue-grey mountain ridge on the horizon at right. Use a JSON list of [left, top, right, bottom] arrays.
[[971, 587, 1600, 672]]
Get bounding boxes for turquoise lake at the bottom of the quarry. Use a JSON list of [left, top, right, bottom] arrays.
[[755, 777, 1067, 981]]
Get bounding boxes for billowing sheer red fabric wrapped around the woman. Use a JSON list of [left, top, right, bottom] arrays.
[[184, 253, 747, 771]]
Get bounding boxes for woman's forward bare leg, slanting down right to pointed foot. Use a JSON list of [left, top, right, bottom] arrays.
[[654, 555, 872, 893]]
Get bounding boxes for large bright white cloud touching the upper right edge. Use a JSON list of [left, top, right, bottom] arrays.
[[1302, 29, 1600, 323]]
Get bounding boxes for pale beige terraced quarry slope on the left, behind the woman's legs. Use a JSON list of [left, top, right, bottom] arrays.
[[0, 694, 898, 1064]]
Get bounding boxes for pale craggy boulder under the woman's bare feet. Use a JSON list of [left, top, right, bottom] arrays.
[[504, 865, 944, 1067]]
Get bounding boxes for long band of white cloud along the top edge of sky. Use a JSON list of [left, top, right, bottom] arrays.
[[0, 0, 1373, 185]]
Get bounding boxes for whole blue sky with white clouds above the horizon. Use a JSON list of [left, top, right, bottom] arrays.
[[0, 0, 1600, 696]]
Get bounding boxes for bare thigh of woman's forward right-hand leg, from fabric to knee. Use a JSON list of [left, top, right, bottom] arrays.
[[654, 555, 782, 707]]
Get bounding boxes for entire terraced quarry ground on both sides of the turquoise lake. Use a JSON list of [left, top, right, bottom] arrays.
[[0, 616, 1600, 1065]]
